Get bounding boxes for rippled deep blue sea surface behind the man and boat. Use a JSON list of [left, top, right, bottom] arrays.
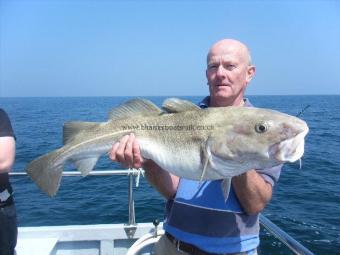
[[0, 96, 340, 254]]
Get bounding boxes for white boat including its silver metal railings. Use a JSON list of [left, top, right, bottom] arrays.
[[10, 169, 313, 255]]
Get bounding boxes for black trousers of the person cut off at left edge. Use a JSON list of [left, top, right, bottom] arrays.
[[0, 204, 18, 255]]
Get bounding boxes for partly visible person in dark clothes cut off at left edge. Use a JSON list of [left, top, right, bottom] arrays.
[[0, 109, 17, 255]]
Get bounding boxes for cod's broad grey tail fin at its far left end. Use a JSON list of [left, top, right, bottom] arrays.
[[26, 150, 63, 197]]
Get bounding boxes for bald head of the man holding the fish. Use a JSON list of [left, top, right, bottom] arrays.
[[206, 39, 255, 106]]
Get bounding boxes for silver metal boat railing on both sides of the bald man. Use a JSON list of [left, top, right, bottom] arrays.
[[10, 169, 314, 255]]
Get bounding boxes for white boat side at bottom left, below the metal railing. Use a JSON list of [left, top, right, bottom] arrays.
[[16, 223, 155, 255]]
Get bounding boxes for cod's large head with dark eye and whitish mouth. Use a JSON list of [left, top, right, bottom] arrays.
[[207, 107, 308, 176]]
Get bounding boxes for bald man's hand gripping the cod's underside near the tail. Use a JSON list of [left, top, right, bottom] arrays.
[[109, 133, 144, 168]]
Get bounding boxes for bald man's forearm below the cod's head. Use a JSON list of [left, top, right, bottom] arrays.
[[232, 170, 272, 214]]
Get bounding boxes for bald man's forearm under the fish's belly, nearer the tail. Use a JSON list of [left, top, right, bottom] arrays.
[[143, 160, 179, 199]]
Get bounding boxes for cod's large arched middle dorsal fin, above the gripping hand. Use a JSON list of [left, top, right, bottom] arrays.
[[109, 98, 162, 120]]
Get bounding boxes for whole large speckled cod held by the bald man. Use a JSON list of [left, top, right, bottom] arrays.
[[26, 98, 309, 197]]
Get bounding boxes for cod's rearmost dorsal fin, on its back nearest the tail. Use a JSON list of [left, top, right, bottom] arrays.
[[63, 121, 100, 144]]
